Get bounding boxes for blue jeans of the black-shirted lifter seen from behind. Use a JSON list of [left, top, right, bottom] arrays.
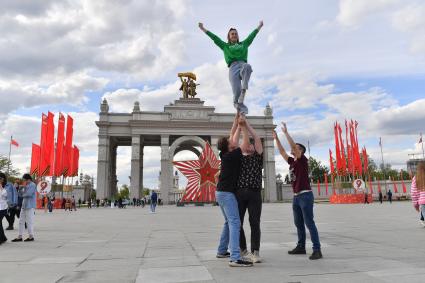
[[215, 191, 241, 261]]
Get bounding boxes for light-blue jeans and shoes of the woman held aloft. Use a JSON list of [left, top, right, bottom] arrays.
[[229, 61, 252, 114]]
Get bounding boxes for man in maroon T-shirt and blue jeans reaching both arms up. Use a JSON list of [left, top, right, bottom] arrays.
[[273, 123, 322, 260]]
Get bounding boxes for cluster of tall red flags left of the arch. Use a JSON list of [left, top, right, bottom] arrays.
[[30, 112, 80, 177]]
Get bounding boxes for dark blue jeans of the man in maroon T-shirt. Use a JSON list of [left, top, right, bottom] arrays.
[[292, 192, 320, 251]]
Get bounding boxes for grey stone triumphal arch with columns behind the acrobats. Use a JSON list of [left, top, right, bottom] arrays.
[[96, 74, 276, 204]]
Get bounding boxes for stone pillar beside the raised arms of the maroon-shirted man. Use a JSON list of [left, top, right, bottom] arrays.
[[264, 135, 277, 202]]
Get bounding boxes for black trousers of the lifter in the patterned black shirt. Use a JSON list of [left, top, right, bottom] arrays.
[[236, 189, 262, 252]]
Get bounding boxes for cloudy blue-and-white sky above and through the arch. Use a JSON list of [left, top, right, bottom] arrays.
[[0, 0, 425, 191]]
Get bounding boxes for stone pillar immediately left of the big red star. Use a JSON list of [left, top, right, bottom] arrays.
[[160, 135, 173, 204]]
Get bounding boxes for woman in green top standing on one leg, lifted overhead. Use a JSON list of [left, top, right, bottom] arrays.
[[199, 21, 263, 114]]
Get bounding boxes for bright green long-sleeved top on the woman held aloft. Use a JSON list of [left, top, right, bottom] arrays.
[[206, 29, 258, 67]]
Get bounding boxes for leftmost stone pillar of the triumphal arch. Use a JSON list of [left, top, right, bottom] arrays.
[[96, 135, 110, 199]]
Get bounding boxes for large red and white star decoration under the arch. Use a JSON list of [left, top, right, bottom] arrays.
[[173, 142, 220, 202]]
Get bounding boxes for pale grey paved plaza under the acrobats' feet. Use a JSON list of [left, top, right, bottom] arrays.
[[0, 202, 425, 283]]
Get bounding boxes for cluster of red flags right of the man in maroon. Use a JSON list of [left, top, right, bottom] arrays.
[[329, 120, 369, 176]]
